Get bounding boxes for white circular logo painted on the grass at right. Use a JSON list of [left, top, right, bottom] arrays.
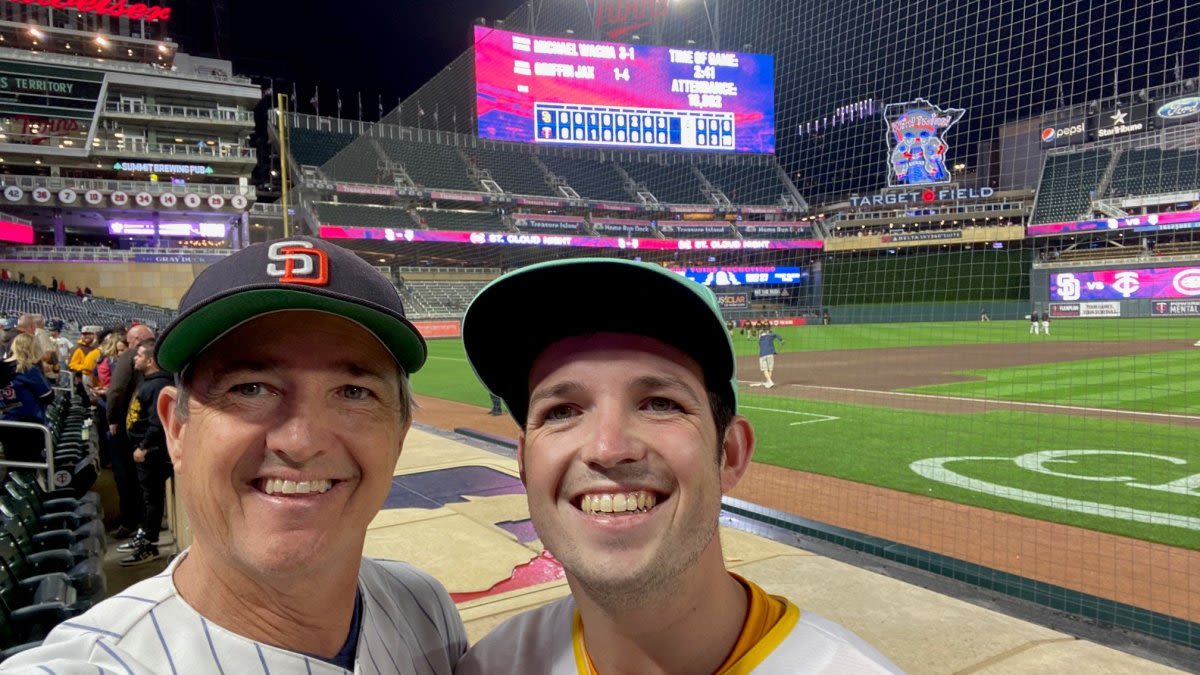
[[908, 449, 1200, 531]]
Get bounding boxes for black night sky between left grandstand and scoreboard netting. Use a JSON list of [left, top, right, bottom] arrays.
[[230, 0, 522, 120]]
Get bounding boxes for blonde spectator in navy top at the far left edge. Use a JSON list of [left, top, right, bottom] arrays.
[[0, 333, 54, 461]]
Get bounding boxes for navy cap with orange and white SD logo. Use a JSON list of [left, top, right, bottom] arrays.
[[156, 237, 427, 375]]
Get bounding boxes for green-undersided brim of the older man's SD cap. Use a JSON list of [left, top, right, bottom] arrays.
[[156, 287, 426, 375]]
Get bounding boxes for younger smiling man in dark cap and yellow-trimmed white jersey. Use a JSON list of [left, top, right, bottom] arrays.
[[458, 258, 898, 675]]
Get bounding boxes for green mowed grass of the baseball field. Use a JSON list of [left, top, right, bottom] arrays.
[[413, 318, 1200, 549]]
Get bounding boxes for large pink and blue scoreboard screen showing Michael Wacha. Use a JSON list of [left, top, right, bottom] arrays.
[[475, 26, 775, 153]]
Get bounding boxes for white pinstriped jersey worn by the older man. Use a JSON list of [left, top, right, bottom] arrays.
[[0, 551, 467, 675]]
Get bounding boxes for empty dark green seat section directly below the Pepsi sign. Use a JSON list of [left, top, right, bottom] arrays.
[[1031, 148, 1111, 223]]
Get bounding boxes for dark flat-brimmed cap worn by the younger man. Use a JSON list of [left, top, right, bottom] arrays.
[[462, 258, 738, 426]]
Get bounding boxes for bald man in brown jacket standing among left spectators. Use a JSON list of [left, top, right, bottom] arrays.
[[104, 324, 154, 539]]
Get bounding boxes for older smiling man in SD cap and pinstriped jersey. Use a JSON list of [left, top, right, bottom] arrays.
[[7, 238, 466, 674]]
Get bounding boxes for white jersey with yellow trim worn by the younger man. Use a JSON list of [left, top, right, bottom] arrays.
[[456, 586, 902, 675]]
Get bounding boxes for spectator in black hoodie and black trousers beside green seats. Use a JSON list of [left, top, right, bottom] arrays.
[[116, 338, 172, 567]]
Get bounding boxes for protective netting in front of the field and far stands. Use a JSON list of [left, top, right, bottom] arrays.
[[280, 0, 1200, 646]]
